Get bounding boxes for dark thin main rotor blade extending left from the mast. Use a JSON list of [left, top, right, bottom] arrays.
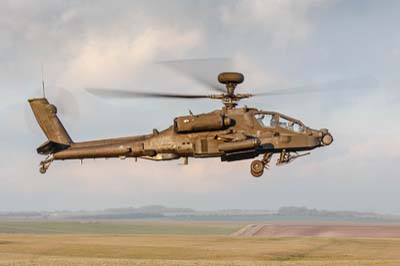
[[86, 88, 209, 99]]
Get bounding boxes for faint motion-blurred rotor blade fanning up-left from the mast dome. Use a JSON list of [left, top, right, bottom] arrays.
[[157, 58, 234, 92]]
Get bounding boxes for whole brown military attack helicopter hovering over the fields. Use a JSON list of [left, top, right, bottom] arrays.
[[28, 72, 333, 177]]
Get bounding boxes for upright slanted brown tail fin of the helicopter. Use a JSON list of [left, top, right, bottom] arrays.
[[29, 98, 73, 146]]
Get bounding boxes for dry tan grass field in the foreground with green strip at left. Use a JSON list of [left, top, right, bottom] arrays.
[[0, 222, 400, 266]]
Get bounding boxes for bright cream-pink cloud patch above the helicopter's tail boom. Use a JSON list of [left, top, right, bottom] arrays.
[[61, 26, 204, 86]]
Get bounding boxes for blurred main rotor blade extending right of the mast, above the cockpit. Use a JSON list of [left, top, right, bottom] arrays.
[[253, 76, 377, 96]]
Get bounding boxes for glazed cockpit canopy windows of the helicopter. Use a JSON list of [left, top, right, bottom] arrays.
[[254, 112, 306, 133]]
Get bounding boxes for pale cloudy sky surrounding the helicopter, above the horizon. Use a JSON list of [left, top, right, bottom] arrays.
[[0, 0, 400, 214]]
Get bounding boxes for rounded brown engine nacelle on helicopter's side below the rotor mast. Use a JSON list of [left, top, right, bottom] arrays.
[[174, 114, 233, 133]]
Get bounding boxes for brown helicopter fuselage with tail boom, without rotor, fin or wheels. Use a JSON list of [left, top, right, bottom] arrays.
[[53, 107, 330, 161]]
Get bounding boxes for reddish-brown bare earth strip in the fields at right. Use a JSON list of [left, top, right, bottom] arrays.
[[232, 224, 400, 238]]
